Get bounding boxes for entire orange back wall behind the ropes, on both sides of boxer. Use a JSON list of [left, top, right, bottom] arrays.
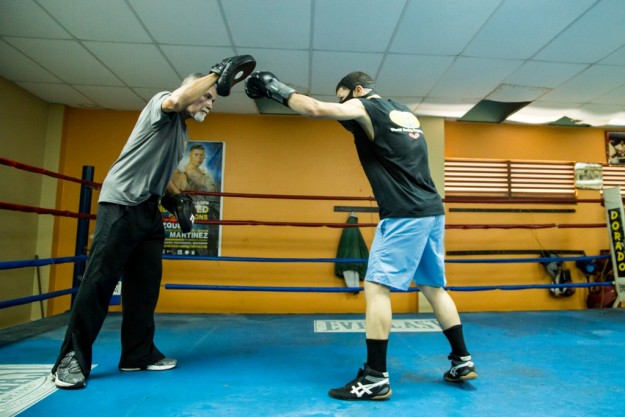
[[50, 109, 607, 314]]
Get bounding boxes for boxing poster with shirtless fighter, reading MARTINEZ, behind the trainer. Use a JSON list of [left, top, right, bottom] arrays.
[[161, 141, 225, 257]]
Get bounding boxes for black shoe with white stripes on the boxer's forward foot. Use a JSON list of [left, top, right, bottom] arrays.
[[328, 364, 393, 400]]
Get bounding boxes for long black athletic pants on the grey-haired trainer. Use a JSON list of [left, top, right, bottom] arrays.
[[53, 196, 165, 377]]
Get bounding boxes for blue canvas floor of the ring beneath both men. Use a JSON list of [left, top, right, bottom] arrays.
[[0, 309, 625, 417]]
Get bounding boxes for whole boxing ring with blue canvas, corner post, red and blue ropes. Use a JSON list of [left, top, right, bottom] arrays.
[[0, 158, 625, 416]]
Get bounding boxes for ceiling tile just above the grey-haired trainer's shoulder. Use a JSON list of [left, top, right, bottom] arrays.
[[83, 42, 182, 88]]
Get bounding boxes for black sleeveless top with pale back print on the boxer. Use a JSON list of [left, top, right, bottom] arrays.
[[349, 98, 445, 219]]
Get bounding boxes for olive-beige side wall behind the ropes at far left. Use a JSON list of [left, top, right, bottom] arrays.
[[0, 77, 64, 328]]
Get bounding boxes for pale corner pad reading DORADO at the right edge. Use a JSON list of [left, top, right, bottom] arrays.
[[603, 186, 625, 306]]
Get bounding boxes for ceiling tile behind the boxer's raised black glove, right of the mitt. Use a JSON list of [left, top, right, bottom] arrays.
[[236, 48, 310, 94]]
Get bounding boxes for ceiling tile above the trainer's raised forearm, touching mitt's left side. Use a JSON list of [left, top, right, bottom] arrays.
[[161, 45, 235, 79]]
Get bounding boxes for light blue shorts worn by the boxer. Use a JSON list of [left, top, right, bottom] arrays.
[[365, 215, 447, 291]]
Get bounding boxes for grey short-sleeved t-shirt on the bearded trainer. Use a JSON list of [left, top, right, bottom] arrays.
[[98, 91, 188, 206]]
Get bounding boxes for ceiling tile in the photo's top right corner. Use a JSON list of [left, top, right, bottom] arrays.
[[535, 0, 625, 64]]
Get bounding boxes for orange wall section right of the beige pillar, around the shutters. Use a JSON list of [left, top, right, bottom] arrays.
[[445, 122, 609, 311]]
